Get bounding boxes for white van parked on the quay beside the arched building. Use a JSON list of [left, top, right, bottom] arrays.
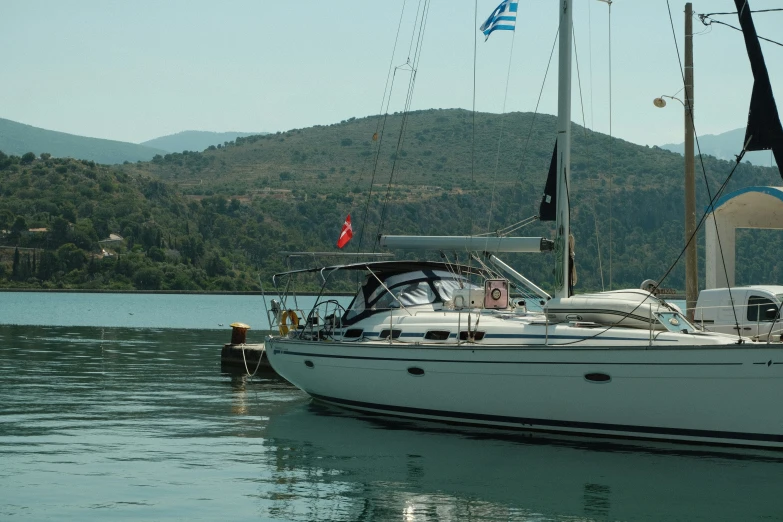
[[693, 285, 783, 341]]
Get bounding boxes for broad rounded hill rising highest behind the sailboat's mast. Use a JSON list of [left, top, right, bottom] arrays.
[[122, 109, 783, 289]]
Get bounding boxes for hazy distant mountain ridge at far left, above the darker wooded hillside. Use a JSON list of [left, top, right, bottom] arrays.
[[0, 118, 165, 164]]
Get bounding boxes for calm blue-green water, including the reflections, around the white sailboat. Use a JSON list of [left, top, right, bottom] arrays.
[[0, 294, 783, 522]]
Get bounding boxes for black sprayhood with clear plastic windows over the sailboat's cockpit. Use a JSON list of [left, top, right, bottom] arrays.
[[342, 270, 480, 325]]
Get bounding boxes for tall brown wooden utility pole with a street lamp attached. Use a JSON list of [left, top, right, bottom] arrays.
[[684, 2, 699, 321]]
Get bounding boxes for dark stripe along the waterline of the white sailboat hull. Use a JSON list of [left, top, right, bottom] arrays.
[[308, 392, 783, 443]]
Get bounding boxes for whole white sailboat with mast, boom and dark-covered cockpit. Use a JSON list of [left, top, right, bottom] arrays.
[[266, 0, 783, 447]]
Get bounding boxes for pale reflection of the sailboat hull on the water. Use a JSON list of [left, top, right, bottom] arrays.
[[265, 403, 783, 521]]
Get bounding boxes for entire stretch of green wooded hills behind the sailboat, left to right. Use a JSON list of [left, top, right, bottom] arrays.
[[0, 110, 783, 291]]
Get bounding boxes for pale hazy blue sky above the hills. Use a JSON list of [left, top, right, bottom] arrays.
[[0, 0, 783, 145]]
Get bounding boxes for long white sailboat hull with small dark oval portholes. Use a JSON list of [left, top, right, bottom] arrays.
[[267, 337, 783, 448]]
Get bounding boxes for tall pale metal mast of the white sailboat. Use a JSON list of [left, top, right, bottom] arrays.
[[555, 0, 573, 298]]
